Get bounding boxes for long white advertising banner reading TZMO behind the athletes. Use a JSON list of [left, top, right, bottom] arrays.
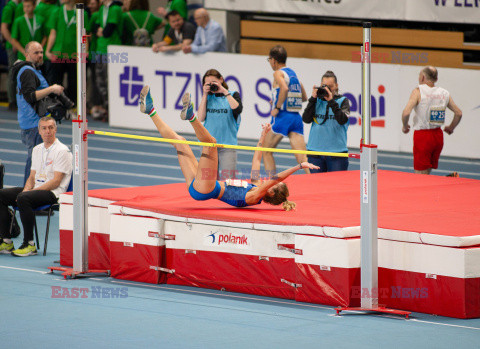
[[108, 46, 480, 158]]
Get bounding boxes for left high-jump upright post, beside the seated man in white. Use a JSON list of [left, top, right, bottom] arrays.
[[72, 4, 88, 272]]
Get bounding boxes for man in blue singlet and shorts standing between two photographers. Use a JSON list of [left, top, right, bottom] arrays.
[[263, 45, 310, 175]]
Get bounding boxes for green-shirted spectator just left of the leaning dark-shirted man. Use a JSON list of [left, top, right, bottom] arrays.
[[123, 0, 164, 47]]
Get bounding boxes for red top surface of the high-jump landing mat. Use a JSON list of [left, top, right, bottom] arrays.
[[113, 171, 480, 237]]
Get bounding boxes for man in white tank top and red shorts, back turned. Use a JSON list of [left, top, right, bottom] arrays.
[[402, 66, 462, 174]]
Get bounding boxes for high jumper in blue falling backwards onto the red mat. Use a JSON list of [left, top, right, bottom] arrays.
[[140, 86, 318, 211]]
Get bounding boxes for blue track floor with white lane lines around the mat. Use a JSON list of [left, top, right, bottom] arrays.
[[0, 108, 480, 348]]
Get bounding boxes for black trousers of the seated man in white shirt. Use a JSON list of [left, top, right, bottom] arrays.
[[0, 187, 57, 242]]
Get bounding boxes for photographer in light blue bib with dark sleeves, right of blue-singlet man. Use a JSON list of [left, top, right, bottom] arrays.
[[302, 70, 350, 173]]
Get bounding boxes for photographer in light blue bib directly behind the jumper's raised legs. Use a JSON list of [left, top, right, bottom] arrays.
[[197, 69, 243, 180]]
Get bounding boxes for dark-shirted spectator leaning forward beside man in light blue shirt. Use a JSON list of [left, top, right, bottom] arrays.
[[152, 11, 195, 52]]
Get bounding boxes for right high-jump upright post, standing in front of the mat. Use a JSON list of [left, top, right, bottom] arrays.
[[360, 23, 378, 309]]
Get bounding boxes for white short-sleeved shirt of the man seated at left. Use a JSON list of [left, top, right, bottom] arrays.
[[31, 139, 72, 198]]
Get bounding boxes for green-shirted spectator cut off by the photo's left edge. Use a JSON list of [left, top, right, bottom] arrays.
[[1, 0, 23, 110]]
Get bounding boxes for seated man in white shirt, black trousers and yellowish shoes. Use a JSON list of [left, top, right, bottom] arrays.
[[0, 116, 72, 257]]
